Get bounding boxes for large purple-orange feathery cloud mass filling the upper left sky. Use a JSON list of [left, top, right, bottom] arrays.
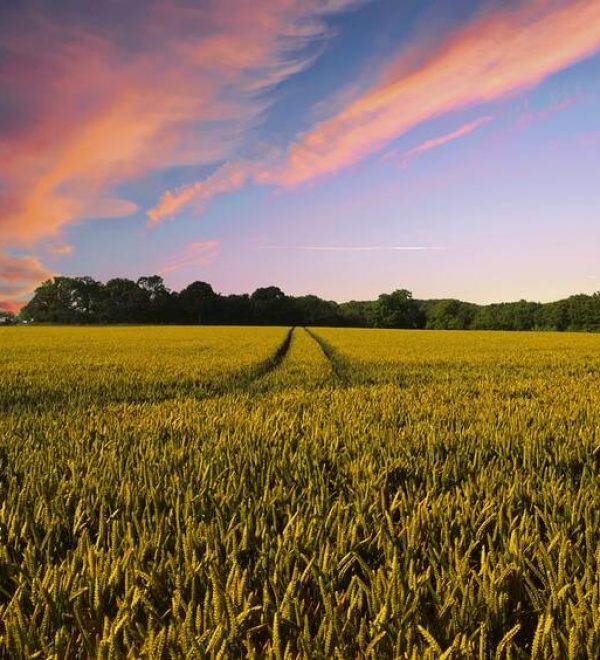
[[0, 0, 360, 247]]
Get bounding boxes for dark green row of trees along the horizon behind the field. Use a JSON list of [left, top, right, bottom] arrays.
[[0, 275, 600, 332]]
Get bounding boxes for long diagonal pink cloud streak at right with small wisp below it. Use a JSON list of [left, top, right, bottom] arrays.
[[150, 0, 600, 223]]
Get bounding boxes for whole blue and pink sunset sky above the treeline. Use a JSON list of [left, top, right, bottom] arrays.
[[0, 0, 600, 311]]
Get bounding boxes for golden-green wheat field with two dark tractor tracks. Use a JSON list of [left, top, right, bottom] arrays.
[[0, 327, 600, 659]]
